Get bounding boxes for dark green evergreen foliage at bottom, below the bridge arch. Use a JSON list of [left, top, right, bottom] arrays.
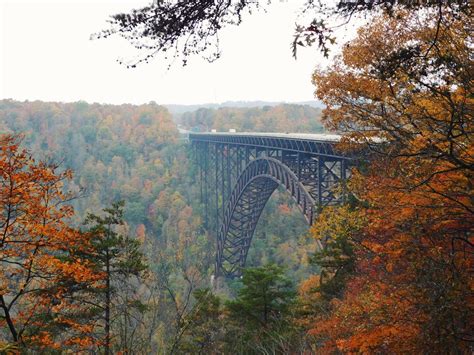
[[177, 264, 305, 354]]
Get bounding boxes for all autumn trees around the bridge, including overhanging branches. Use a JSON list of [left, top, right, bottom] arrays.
[[0, 0, 474, 354]]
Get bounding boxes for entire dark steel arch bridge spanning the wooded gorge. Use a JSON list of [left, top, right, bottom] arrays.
[[189, 133, 350, 278]]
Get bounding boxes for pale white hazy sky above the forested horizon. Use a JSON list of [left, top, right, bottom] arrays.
[[0, 0, 334, 104]]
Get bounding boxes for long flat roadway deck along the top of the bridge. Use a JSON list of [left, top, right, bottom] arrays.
[[189, 132, 341, 158]]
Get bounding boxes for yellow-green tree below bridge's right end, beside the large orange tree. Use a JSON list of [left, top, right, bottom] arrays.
[[296, 206, 367, 353]]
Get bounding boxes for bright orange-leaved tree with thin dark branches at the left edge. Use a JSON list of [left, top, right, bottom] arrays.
[[0, 135, 101, 349]]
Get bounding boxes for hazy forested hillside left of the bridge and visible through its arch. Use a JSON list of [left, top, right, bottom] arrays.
[[0, 100, 316, 351]]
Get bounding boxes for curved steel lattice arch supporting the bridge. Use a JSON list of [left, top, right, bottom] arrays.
[[216, 157, 315, 277]]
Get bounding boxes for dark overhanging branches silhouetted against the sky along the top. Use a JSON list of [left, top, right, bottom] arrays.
[[95, 0, 470, 67]]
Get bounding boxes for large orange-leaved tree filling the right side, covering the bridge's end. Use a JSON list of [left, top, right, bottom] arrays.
[[303, 5, 474, 353]]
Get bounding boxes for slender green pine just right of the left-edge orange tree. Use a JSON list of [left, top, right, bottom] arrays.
[[84, 201, 147, 354]]
